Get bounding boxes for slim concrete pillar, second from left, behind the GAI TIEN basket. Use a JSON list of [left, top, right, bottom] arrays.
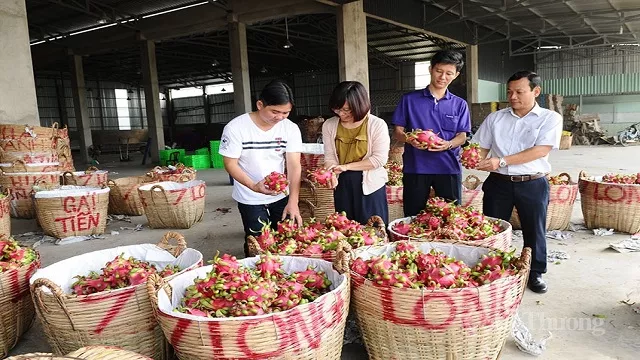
[[69, 55, 93, 164]]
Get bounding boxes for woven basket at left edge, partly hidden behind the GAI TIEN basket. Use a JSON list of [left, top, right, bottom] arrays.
[[0, 172, 60, 219]]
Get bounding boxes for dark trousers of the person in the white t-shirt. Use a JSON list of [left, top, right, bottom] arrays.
[[238, 196, 289, 257]]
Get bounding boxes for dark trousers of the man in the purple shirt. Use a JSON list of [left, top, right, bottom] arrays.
[[402, 174, 462, 216]]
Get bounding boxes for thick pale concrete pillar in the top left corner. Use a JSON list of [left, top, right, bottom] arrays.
[[0, 0, 40, 126]]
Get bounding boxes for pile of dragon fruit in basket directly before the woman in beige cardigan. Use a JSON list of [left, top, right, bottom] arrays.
[[256, 212, 385, 255]]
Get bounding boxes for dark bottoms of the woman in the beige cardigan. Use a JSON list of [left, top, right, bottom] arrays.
[[333, 171, 389, 224]]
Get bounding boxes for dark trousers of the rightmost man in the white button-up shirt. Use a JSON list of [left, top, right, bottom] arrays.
[[482, 175, 549, 276]]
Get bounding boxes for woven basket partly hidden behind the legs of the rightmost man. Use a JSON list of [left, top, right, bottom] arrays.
[[509, 173, 578, 230]]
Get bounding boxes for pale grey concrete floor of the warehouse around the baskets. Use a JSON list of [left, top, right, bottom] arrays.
[[6, 146, 640, 360]]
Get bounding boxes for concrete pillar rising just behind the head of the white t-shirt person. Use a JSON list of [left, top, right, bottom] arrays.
[[229, 19, 251, 115]]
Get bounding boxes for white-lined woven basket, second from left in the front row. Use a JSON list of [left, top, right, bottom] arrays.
[[30, 232, 202, 360]]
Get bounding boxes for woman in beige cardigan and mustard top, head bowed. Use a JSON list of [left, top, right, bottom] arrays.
[[322, 81, 390, 223]]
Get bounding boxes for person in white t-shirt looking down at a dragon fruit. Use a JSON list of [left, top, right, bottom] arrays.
[[219, 80, 302, 256]]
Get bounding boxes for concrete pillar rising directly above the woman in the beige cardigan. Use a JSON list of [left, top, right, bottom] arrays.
[[337, 0, 369, 90]]
